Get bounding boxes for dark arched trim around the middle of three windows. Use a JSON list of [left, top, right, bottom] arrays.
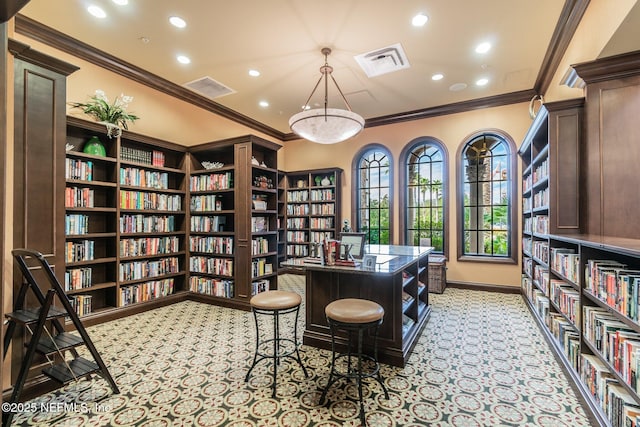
[[398, 136, 450, 259]]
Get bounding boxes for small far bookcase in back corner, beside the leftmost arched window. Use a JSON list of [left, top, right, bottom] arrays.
[[280, 168, 342, 259]]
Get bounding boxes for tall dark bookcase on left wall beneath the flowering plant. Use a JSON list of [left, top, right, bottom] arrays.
[[63, 117, 186, 323]]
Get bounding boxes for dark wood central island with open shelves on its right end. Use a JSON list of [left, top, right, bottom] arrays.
[[292, 245, 432, 367]]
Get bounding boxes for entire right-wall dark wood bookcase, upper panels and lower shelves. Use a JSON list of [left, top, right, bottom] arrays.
[[520, 52, 640, 426]]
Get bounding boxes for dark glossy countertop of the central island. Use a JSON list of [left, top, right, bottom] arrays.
[[281, 245, 433, 274]]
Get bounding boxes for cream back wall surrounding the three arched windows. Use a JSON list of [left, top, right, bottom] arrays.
[[280, 103, 531, 286]]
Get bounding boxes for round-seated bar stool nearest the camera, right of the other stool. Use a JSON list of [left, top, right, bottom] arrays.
[[320, 298, 389, 425]]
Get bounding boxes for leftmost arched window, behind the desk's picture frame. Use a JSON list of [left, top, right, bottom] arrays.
[[353, 144, 392, 244]]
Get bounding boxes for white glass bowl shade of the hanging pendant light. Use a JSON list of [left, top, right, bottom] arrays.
[[289, 108, 364, 144]]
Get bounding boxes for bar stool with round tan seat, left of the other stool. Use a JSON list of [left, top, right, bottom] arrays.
[[244, 291, 309, 397]]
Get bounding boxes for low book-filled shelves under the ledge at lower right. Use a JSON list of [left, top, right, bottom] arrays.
[[534, 234, 640, 426]]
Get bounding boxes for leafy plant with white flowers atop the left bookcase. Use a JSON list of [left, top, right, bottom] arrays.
[[69, 90, 140, 138]]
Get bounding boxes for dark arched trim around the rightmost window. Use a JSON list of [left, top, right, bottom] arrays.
[[456, 129, 520, 264]]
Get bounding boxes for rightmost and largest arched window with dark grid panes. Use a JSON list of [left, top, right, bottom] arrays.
[[458, 132, 517, 262]]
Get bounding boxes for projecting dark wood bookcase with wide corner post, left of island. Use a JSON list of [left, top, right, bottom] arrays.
[[189, 136, 280, 309]]
